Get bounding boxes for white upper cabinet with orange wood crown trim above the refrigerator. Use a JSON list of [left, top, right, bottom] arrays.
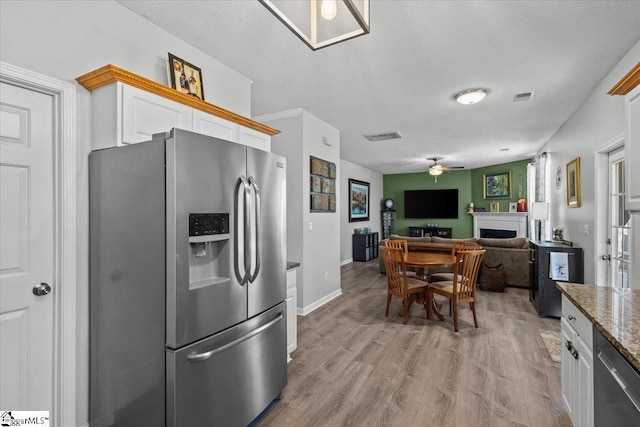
[[76, 65, 278, 151]]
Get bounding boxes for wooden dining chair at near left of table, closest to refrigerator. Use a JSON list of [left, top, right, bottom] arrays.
[[380, 246, 427, 325]]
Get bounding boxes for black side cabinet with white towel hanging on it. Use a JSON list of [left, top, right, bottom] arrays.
[[529, 240, 584, 317]]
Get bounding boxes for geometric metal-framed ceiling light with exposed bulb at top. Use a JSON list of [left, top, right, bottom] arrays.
[[258, 0, 369, 50]]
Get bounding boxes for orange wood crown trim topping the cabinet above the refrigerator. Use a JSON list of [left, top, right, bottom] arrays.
[[76, 64, 280, 136]]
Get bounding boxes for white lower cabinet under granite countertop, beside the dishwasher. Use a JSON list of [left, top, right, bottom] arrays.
[[560, 296, 593, 427]]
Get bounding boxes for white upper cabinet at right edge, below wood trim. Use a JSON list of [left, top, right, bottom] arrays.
[[624, 86, 640, 211]]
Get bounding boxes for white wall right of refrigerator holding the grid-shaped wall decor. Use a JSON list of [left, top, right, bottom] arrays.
[[262, 109, 345, 315]]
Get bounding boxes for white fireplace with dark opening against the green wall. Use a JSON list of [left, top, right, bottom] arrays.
[[471, 212, 527, 239]]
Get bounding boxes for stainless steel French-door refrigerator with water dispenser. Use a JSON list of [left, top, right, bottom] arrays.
[[89, 129, 287, 427]]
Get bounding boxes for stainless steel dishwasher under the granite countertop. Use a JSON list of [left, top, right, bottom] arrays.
[[593, 326, 640, 427]]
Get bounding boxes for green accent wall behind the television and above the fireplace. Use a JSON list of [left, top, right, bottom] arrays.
[[382, 159, 530, 239]]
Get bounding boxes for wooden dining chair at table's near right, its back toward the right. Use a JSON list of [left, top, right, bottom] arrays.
[[427, 250, 485, 332]]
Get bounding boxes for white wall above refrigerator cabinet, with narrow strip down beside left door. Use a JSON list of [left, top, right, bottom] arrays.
[[0, 1, 251, 425]]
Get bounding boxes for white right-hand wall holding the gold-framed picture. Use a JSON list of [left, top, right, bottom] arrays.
[[538, 38, 640, 285]]
